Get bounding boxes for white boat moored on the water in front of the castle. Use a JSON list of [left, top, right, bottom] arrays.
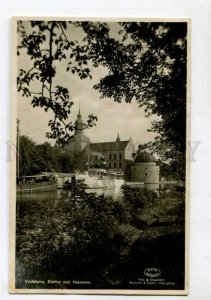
[[76, 168, 124, 189]]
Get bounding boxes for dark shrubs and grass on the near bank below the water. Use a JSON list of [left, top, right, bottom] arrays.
[[16, 182, 184, 289]]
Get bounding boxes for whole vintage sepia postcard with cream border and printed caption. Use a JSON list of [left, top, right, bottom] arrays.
[[10, 17, 190, 295]]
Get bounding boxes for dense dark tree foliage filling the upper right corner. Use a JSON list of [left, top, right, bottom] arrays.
[[79, 22, 187, 177]]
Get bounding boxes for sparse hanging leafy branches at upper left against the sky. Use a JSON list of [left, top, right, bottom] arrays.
[[17, 21, 97, 145]]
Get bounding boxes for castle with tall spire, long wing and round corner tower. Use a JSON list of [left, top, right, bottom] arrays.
[[64, 110, 160, 184]]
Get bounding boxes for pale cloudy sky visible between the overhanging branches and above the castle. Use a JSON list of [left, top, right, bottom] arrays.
[[17, 23, 156, 145]]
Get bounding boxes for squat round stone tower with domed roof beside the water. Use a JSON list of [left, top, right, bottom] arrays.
[[131, 151, 160, 183]]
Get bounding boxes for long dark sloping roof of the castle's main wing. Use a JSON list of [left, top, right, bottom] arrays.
[[90, 140, 129, 152]]
